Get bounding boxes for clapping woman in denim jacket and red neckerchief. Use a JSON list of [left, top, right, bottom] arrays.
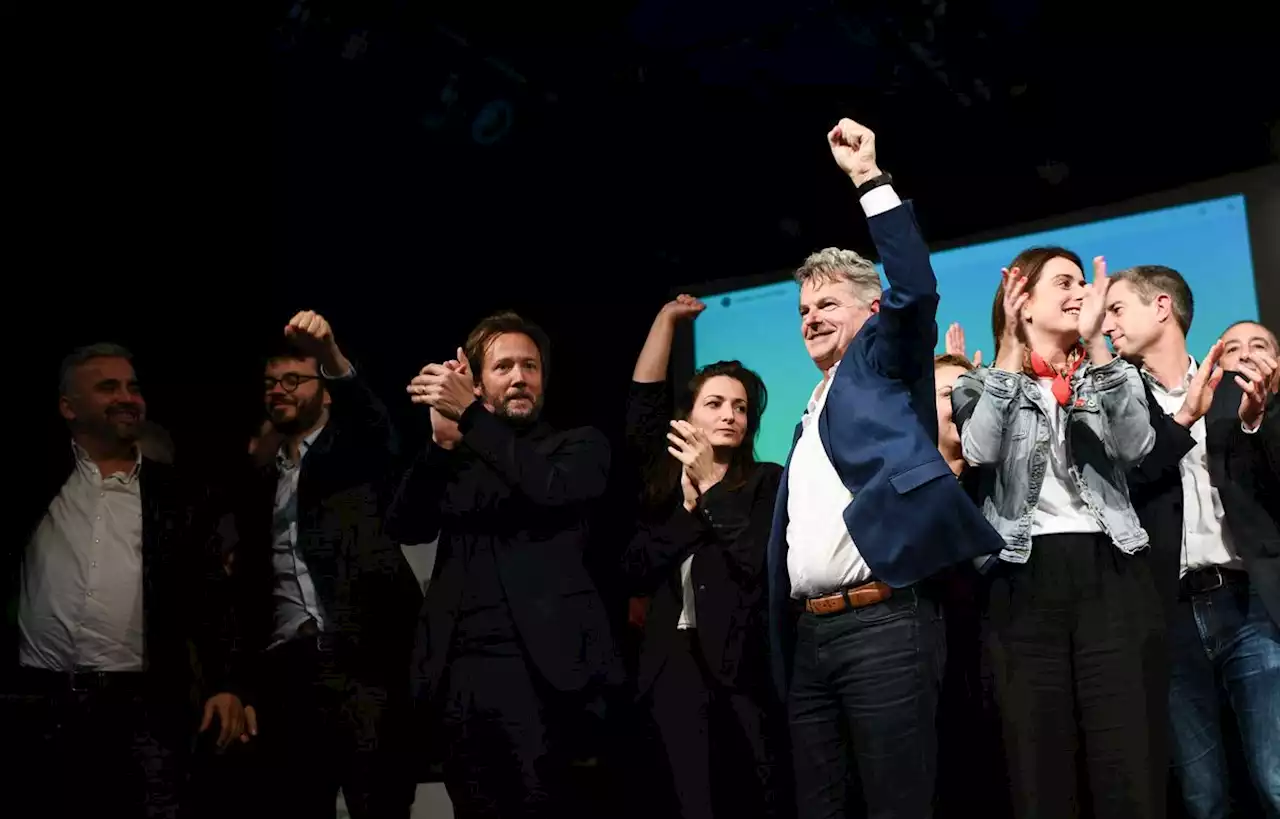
[[952, 247, 1169, 819]]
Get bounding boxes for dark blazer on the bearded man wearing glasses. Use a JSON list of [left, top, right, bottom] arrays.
[[232, 375, 422, 685]]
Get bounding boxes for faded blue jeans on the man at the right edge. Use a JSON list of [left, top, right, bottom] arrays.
[[1169, 573, 1280, 819]]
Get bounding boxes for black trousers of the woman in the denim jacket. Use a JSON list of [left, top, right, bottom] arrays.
[[987, 534, 1169, 819]]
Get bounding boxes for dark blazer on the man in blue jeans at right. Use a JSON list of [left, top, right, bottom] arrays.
[[1129, 374, 1280, 623]]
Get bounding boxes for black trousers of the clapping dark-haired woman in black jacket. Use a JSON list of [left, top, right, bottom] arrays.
[[649, 630, 794, 819]]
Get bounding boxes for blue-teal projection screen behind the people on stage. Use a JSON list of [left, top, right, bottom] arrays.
[[691, 181, 1266, 463]]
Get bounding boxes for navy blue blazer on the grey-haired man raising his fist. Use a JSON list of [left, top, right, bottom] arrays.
[[769, 203, 1004, 691]]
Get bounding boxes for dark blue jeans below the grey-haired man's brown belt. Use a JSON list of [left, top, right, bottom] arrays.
[[787, 589, 946, 819]]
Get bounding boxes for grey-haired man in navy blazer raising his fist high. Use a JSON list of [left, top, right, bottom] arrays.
[[769, 119, 1004, 819]]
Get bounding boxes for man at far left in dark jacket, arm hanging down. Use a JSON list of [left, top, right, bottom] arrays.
[[0, 344, 243, 816]]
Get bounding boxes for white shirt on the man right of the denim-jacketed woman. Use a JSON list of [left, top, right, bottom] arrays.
[[1146, 357, 1244, 575]]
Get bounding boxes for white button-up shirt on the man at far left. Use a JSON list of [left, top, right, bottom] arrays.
[[18, 443, 143, 672]]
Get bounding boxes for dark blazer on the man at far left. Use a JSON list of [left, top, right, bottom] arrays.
[[0, 441, 230, 697]]
